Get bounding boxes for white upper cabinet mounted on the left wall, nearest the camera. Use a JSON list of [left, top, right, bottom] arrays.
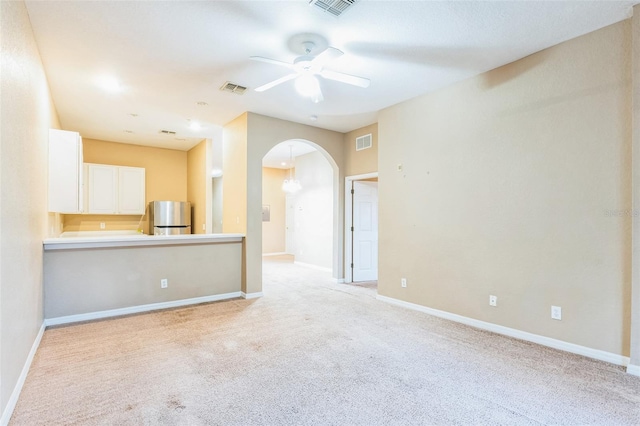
[[48, 129, 84, 213]]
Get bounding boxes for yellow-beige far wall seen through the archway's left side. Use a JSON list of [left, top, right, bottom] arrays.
[[262, 167, 288, 253]]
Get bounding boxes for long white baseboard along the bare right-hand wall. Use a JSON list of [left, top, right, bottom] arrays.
[[376, 295, 640, 368]]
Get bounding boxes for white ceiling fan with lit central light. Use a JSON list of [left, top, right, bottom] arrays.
[[250, 41, 371, 103]]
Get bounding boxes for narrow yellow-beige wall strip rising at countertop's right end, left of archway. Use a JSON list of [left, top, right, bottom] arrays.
[[222, 113, 248, 234]]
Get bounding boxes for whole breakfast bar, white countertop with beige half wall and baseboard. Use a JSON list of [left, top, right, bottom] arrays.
[[43, 232, 244, 325]]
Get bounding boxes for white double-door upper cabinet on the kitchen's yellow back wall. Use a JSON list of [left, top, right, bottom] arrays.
[[86, 163, 146, 215]]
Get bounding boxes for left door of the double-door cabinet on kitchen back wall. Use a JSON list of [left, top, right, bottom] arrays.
[[87, 164, 118, 214]]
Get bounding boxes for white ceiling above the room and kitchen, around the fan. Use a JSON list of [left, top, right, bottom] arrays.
[[26, 0, 638, 150]]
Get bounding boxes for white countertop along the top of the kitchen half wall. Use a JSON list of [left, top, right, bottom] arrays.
[[42, 232, 244, 250]]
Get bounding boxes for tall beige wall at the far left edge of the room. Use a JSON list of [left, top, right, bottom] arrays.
[[0, 1, 60, 421]]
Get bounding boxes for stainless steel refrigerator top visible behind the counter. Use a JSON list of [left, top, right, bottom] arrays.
[[149, 201, 191, 235]]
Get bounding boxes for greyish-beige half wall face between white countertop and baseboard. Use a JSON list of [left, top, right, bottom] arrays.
[[44, 243, 242, 318]]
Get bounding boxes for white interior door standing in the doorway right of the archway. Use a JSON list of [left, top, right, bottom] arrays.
[[352, 181, 378, 281]]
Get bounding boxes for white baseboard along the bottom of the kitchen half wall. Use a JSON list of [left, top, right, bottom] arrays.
[[44, 291, 242, 327]]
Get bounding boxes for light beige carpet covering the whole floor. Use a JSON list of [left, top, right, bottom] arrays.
[[10, 255, 640, 426]]
